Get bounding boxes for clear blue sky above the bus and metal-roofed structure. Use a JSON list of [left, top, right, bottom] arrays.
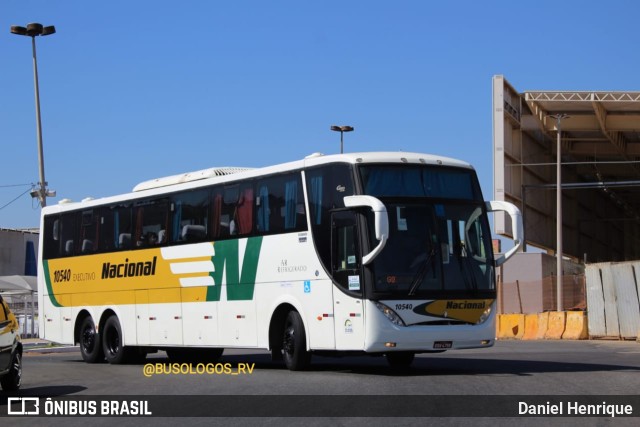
[[0, 0, 640, 228]]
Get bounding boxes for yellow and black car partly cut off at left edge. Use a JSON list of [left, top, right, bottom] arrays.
[[0, 295, 22, 391]]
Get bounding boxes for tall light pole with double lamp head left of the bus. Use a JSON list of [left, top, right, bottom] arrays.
[[11, 22, 56, 207]]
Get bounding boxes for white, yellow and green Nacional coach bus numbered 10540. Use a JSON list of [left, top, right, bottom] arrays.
[[38, 152, 522, 370]]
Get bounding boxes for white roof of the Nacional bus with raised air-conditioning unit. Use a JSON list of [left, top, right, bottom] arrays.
[[38, 151, 473, 213]]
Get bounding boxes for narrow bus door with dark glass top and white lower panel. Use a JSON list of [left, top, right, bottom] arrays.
[[331, 211, 365, 350]]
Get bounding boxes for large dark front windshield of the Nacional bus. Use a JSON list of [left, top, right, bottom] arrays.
[[360, 165, 495, 298]]
